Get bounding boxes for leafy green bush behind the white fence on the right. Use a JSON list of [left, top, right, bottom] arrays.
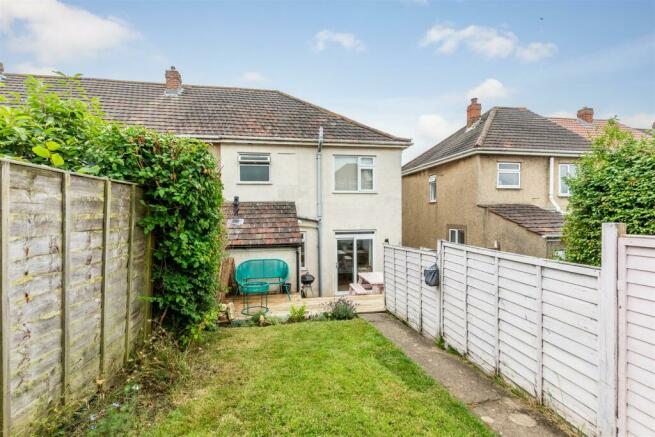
[[564, 121, 655, 265]]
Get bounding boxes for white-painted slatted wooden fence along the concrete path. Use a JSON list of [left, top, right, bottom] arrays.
[[384, 225, 655, 436]]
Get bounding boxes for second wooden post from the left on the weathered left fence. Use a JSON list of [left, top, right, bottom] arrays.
[[61, 173, 71, 403]]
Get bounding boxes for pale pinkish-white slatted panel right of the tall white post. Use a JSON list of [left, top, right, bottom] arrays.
[[617, 236, 655, 436]]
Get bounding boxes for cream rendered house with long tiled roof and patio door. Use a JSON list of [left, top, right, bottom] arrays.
[[0, 64, 411, 296]]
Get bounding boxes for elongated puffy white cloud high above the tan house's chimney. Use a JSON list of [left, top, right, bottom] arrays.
[[420, 24, 557, 62]]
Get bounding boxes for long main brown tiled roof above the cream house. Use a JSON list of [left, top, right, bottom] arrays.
[[0, 73, 411, 146]]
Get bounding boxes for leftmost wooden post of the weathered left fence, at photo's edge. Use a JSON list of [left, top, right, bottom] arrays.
[[0, 161, 11, 436]]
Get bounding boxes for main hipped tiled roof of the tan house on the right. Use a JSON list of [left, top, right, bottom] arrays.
[[403, 107, 590, 173]]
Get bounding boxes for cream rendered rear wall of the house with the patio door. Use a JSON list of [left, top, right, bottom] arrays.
[[219, 143, 402, 296]]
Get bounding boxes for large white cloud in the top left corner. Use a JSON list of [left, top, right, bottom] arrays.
[[0, 0, 138, 68]]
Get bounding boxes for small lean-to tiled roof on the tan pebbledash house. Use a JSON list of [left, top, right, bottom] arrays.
[[479, 203, 564, 236]]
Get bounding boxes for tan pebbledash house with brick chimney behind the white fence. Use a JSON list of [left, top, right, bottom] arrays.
[[402, 99, 645, 257]]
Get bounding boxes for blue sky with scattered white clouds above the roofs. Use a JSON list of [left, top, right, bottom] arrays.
[[0, 0, 655, 162]]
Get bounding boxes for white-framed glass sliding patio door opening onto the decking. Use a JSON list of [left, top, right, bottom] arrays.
[[337, 233, 373, 293]]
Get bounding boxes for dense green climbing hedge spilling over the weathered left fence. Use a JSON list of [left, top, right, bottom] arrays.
[[0, 76, 222, 339]]
